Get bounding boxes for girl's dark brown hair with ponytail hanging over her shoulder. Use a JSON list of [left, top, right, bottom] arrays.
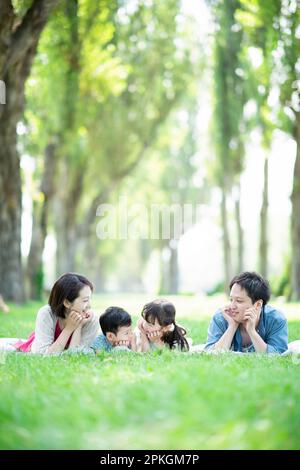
[[142, 299, 189, 350]]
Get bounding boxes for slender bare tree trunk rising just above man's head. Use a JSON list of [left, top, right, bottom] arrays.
[[258, 156, 269, 278]]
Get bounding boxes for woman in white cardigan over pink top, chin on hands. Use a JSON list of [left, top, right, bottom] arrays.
[[0, 273, 98, 354]]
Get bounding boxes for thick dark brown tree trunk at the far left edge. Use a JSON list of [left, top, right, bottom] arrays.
[[0, 0, 57, 302]]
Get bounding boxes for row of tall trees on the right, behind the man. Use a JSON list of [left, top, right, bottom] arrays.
[[208, 0, 300, 299]]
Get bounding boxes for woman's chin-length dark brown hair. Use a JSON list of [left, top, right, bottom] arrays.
[[48, 273, 93, 318]]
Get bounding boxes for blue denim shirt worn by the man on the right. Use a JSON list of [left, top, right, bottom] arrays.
[[205, 305, 288, 354]]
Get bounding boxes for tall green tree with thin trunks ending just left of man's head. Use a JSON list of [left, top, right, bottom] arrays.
[[209, 0, 245, 285]]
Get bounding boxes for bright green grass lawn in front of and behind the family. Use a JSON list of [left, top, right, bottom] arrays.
[[0, 295, 300, 450]]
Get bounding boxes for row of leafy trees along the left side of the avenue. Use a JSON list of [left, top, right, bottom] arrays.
[[0, 0, 202, 300]]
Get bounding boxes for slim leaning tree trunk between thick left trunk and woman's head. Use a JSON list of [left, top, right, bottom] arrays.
[[27, 143, 58, 299]]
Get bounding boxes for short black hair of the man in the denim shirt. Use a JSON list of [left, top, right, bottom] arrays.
[[229, 271, 271, 306]]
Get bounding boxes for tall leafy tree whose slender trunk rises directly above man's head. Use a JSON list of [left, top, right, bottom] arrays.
[[236, 0, 281, 277]]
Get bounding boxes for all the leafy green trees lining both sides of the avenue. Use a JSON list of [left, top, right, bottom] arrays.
[[0, 0, 300, 301]]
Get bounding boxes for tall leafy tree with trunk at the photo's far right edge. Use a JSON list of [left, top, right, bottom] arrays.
[[238, 0, 300, 300]]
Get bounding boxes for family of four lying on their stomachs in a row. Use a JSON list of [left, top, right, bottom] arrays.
[[0, 272, 300, 354]]
